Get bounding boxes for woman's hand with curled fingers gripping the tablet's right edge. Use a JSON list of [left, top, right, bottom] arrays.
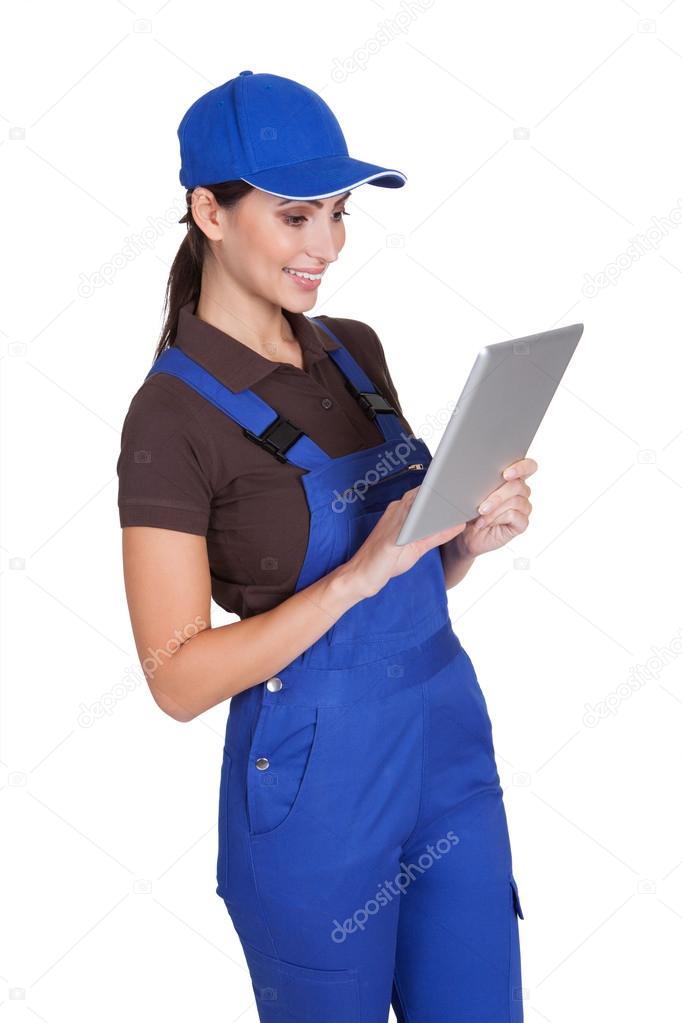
[[454, 458, 538, 558]]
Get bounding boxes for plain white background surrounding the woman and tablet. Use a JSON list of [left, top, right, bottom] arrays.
[[0, 0, 682, 1023]]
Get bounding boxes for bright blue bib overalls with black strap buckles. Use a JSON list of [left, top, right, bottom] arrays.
[[150, 320, 524, 1023]]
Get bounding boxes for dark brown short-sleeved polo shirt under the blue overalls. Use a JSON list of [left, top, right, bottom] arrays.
[[117, 302, 412, 618]]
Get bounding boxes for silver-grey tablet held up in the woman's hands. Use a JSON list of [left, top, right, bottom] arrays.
[[396, 323, 584, 545]]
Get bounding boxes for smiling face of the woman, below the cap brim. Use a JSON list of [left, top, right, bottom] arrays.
[[208, 188, 351, 312]]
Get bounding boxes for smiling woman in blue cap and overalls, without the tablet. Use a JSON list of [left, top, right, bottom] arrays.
[[118, 71, 537, 1023]]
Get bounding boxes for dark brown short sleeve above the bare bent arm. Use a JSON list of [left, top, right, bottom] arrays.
[[117, 377, 213, 536]]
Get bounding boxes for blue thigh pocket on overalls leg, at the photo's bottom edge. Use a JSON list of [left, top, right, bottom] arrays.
[[241, 941, 360, 1023]]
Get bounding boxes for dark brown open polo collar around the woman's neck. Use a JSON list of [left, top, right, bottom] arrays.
[[177, 299, 342, 391]]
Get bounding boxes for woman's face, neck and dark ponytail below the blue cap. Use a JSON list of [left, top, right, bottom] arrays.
[[156, 181, 351, 361]]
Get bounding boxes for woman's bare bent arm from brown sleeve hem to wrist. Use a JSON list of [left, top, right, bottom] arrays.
[[123, 526, 363, 721]]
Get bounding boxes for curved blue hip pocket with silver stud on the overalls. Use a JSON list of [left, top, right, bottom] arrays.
[[246, 704, 318, 836]]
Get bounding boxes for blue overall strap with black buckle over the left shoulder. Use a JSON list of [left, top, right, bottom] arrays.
[[145, 345, 331, 470]]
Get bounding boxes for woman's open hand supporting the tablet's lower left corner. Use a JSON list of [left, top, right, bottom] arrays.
[[347, 486, 466, 597]]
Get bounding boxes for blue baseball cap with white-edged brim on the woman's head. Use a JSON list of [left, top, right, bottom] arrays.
[[178, 71, 407, 198]]
